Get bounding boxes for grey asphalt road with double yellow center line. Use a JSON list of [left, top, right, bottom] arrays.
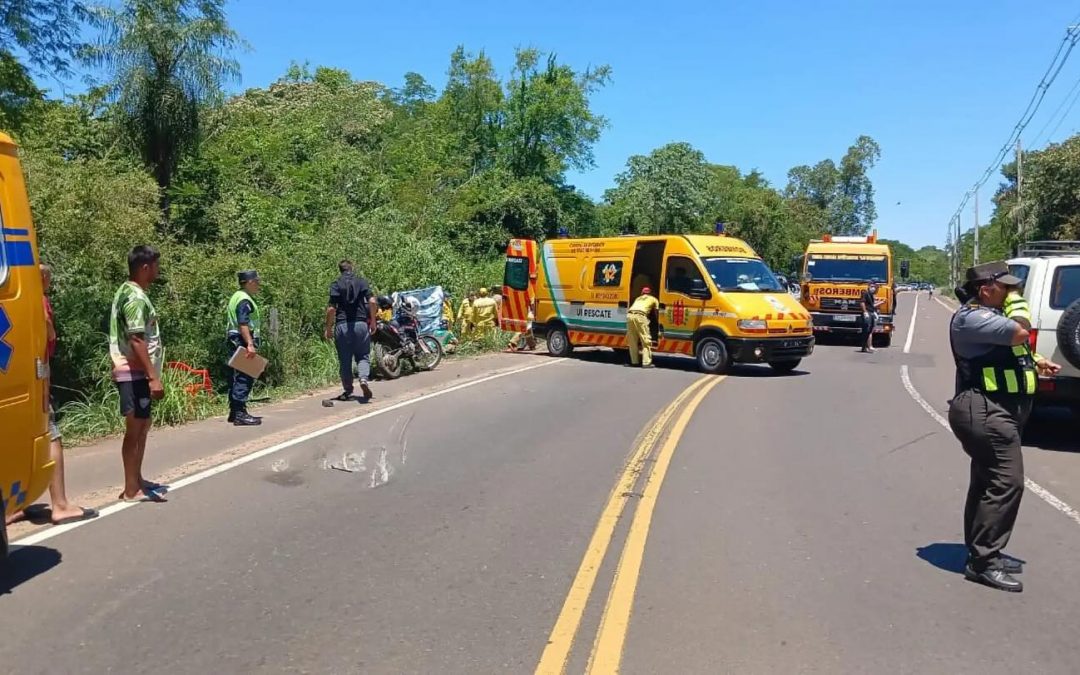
[[0, 295, 1080, 675]]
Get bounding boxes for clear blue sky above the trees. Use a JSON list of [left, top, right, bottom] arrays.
[[46, 0, 1080, 245]]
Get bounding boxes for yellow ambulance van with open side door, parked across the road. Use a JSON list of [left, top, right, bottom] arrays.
[[502, 228, 814, 373]]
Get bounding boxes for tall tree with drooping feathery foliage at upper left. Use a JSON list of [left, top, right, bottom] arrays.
[[84, 0, 241, 222]]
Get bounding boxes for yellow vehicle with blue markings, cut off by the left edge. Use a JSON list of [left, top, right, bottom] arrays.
[[0, 133, 54, 561]]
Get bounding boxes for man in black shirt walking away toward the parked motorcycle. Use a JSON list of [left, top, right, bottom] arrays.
[[326, 260, 378, 401]]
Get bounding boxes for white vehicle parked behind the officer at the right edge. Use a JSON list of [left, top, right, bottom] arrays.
[[1009, 241, 1080, 416]]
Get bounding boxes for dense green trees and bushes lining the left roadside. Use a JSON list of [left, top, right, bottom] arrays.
[[0, 0, 935, 430]]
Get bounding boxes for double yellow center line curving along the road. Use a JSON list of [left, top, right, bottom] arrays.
[[536, 376, 724, 675]]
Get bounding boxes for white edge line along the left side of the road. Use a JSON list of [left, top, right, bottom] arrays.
[[11, 359, 566, 550]]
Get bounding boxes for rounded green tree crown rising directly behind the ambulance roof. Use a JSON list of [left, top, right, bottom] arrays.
[[604, 143, 713, 234]]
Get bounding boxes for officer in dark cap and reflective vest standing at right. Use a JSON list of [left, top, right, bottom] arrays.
[[948, 261, 1059, 593]]
